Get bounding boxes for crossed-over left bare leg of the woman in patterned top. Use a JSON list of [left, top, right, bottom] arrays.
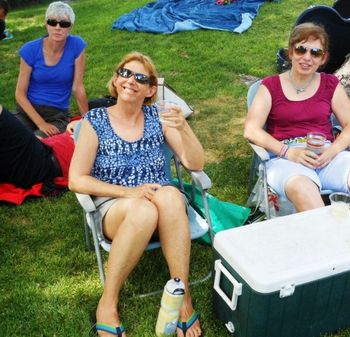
[[96, 198, 158, 337]]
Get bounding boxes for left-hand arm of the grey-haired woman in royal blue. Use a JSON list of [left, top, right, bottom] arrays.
[[16, 58, 59, 136]]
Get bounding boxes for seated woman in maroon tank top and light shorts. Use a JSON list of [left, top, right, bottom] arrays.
[[244, 23, 350, 211]]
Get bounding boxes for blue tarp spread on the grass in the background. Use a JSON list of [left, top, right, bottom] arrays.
[[112, 0, 264, 34]]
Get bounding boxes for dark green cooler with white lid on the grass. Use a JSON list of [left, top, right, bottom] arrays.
[[213, 206, 350, 337]]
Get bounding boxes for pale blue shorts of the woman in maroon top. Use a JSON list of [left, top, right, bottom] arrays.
[[266, 151, 350, 197]]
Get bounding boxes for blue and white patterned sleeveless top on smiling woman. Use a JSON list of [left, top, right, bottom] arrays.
[[84, 105, 169, 187]]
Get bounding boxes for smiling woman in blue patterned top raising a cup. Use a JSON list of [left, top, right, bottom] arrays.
[[69, 52, 204, 337]]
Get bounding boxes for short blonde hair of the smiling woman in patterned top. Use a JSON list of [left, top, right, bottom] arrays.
[[107, 52, 158, 105]]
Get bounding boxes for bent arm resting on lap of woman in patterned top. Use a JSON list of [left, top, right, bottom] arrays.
[[69, 120, 161, 199]]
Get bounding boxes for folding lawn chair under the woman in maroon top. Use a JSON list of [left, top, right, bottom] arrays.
[[246, 80, 341, 219]]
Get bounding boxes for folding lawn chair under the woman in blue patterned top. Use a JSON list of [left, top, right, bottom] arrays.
[[74, 121, 213, 288]]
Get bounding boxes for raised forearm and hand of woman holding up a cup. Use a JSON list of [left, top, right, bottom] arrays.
[[162, 106, 204, 171]]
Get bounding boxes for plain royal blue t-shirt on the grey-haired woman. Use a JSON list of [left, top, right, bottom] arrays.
[[19, 35, 86, 110]]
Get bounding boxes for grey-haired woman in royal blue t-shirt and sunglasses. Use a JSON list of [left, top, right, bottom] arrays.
[[16, 1, 88, 137]]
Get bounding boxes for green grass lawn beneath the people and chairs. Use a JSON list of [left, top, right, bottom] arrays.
[[0, 0, 350, 337]]
